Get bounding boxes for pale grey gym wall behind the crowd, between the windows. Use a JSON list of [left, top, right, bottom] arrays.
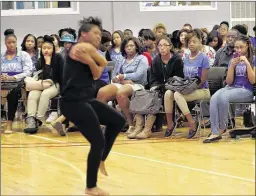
[[1, 2, 230, 48]]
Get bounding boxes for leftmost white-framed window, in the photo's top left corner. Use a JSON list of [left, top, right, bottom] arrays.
[[1, 1, 79, 16]]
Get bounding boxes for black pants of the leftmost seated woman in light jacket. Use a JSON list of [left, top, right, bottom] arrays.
[[7, 87, 21, 121]]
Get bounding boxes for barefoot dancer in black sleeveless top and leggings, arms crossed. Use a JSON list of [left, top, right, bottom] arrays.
[[60, 17, 125, 195]]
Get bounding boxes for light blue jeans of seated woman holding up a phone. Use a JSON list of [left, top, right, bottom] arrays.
[[210, 86, 253, 134]]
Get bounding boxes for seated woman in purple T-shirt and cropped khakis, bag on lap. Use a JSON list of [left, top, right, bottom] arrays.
[[164, 31, 210, 139]]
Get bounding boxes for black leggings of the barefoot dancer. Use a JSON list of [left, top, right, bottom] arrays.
[[60, 99, 125, 188]]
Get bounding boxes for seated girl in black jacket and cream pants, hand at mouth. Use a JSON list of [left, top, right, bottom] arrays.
[[24, 35, 64, 133]]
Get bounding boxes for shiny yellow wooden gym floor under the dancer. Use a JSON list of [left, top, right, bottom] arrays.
[[1, 121, 255, 195]]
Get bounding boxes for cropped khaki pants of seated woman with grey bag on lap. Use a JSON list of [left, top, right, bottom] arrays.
[[164, 89, 211, 115]]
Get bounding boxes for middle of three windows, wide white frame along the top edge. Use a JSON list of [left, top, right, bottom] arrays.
[[140, 0, 217, 11]]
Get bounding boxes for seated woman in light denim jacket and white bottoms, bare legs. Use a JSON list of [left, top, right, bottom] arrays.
[[97, 37, 149, 133]]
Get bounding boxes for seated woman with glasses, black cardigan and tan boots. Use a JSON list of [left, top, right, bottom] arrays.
[[127, 37, 184, 139]]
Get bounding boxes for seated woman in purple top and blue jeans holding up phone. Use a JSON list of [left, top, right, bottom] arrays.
[[204, 34, 255, 143]]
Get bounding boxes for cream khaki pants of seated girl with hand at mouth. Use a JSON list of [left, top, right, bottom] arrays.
[[27, 84, 59, 120]]
